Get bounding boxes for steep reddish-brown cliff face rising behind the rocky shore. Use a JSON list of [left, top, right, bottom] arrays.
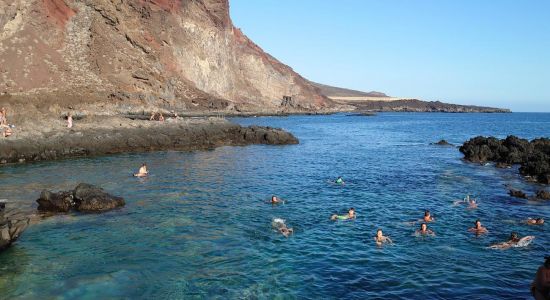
[[0, 0, 332, 110]]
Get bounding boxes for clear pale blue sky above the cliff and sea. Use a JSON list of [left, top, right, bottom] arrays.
[[230, 0, 550, 112]]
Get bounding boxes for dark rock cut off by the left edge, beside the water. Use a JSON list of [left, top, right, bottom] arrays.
[[0, 202, 30, 251]]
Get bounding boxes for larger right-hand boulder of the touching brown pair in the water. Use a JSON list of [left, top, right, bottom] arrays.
[[73, 183, 125, 212]]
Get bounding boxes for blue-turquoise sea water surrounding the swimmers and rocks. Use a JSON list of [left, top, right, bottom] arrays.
[[0, 113, 550, 299]]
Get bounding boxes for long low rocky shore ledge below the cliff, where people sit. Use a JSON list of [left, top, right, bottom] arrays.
[[0, 118, 298, 165]]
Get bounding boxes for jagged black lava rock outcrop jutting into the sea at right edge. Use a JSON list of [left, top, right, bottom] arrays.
[[460, 136, 550, 184]]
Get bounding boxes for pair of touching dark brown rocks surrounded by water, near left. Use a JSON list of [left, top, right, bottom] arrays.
[[36, 183, 125, 213]]
